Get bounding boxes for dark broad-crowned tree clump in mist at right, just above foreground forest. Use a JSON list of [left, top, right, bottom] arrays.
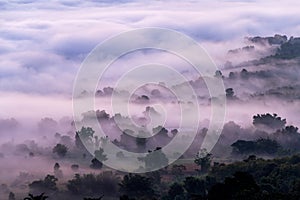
[[227, 113, 300, 156]]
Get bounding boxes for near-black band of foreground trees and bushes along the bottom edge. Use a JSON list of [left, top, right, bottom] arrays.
[[14, 155, 300, 200]]
